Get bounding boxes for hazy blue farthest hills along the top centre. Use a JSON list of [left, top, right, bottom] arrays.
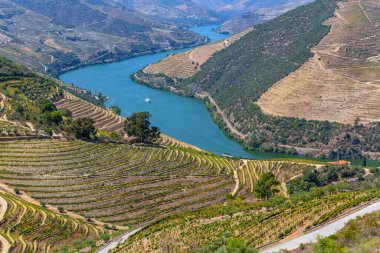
[[111, 0, 312, 27]]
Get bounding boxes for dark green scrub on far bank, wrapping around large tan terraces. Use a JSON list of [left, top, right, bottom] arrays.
[[134, 0, 380, 158]]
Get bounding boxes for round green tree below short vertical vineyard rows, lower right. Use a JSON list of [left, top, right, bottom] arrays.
[[253, 172, 280, 200]]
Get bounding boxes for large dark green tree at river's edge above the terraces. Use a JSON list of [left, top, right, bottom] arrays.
[[125, 112, 160, 142]]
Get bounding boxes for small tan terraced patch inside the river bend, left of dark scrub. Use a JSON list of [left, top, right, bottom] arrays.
[[143, 28, 253, 79]]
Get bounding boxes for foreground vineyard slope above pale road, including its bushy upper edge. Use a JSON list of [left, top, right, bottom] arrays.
[[114, 172, 380, 252]]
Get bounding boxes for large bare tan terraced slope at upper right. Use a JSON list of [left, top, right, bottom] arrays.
[[257, 0, 380, 123]]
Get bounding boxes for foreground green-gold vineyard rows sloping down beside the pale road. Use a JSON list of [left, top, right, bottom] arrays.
[[113, 189, 380, 253]]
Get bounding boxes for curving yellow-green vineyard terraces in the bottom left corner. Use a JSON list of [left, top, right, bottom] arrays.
[[0, 191, 104, 252]]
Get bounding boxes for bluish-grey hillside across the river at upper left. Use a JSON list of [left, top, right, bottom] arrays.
[[0, 0, 205, 75]]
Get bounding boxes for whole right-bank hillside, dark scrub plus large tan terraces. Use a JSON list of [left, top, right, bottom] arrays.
[[134, 0, 380, 158]]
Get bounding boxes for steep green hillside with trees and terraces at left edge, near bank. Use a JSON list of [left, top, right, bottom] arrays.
[[0, 57, 64, 135]]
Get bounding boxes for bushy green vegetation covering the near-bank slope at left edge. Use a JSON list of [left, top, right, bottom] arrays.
[[0, 57, 64, 131]]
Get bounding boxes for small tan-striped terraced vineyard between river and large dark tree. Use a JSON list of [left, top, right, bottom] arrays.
[[56, 92, 125, 132]]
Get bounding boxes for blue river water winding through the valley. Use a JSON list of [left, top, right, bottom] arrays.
[[60, 26, 378, 165]]
